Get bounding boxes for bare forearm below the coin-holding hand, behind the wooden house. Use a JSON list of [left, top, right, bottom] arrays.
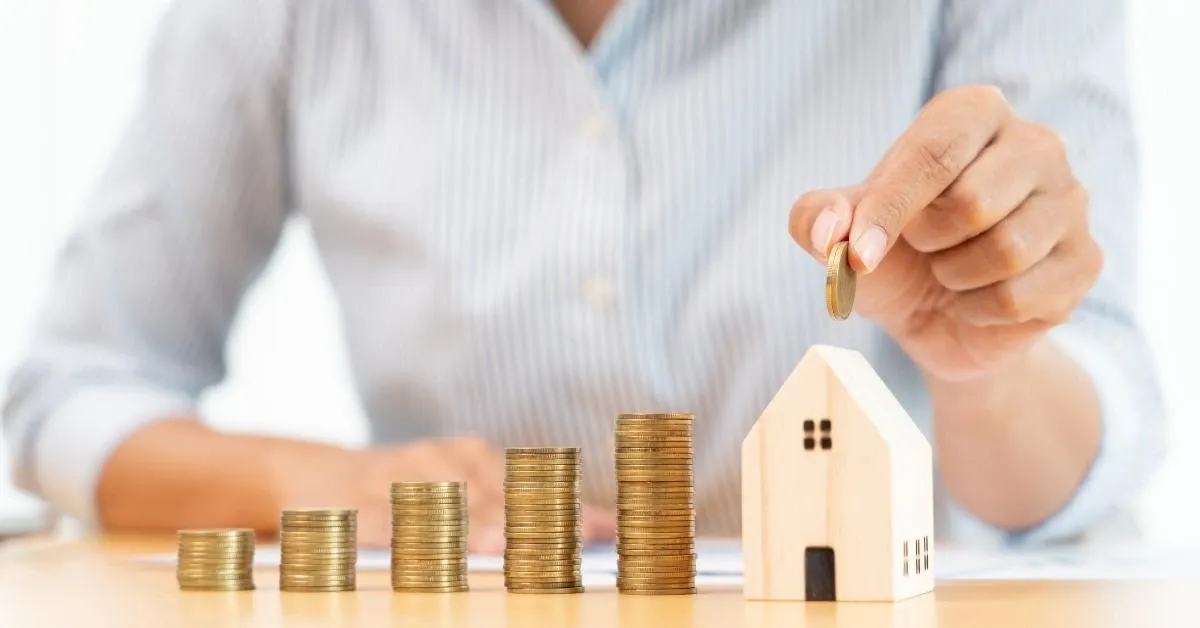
[[928, 341, 1100, 532]]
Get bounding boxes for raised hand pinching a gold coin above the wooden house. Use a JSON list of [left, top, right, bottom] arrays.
[[788, 86, 1103, 379]]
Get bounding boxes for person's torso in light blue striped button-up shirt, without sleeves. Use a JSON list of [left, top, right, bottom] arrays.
[[288, 0, 940, 534]]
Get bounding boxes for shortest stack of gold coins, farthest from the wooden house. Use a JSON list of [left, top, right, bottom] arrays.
[[175, 528, 254, 591]]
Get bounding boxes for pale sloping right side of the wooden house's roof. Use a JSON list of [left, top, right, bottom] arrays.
[[802, 345, 930, 453]]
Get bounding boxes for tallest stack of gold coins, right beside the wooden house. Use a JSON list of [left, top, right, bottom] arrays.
[[616, 413, 696, 594]]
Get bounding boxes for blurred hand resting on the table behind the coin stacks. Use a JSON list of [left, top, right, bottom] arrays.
[[273, 437, 617, 554]]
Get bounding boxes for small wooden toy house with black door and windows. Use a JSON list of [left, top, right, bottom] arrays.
[[742, 346, 934, 602]]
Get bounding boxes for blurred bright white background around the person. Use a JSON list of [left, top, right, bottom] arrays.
[[0, 0, 1200, 544]]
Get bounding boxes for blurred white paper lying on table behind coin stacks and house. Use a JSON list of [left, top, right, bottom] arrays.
[[137, 540, 1200, 586]]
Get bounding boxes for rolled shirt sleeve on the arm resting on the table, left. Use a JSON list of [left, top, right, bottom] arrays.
[[4, 0, 287, 524]]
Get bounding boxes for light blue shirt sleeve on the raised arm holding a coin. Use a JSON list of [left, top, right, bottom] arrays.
[[935, 0, 1164, 545]]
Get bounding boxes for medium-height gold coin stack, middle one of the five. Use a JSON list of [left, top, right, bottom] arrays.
[[391, 482, 468, 593]]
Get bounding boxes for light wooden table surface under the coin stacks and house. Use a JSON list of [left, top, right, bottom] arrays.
[[0, 537, 1200, 628]]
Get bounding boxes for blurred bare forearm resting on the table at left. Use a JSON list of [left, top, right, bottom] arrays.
[[96, 419, 347, 534]]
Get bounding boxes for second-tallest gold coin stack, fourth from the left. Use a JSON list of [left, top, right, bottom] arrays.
[[504, 447, 583, 593]]
